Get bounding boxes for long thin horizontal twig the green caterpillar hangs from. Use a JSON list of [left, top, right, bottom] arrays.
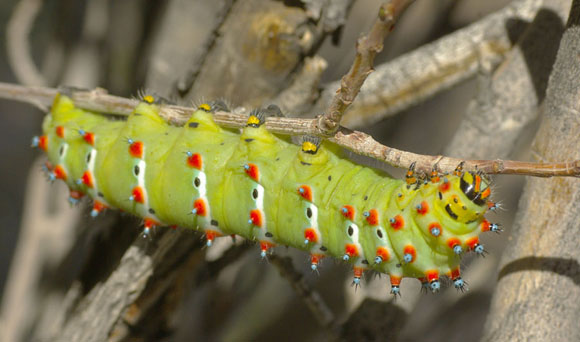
[[0, 82, 580, 177]]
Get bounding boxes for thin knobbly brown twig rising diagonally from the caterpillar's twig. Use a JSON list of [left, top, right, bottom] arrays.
[[318, 0, 414, 137]]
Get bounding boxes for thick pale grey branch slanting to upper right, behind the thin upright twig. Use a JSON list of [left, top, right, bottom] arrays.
[[314, 0, 544, 129]]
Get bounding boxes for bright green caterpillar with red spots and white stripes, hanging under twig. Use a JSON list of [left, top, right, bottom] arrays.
[[32, 94, 501, 296]]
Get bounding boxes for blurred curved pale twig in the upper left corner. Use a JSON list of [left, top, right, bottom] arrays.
[[6, 0, 46, 85]]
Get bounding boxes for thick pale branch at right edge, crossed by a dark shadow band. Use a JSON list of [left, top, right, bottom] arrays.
[[483, 0, 580, 342]]
